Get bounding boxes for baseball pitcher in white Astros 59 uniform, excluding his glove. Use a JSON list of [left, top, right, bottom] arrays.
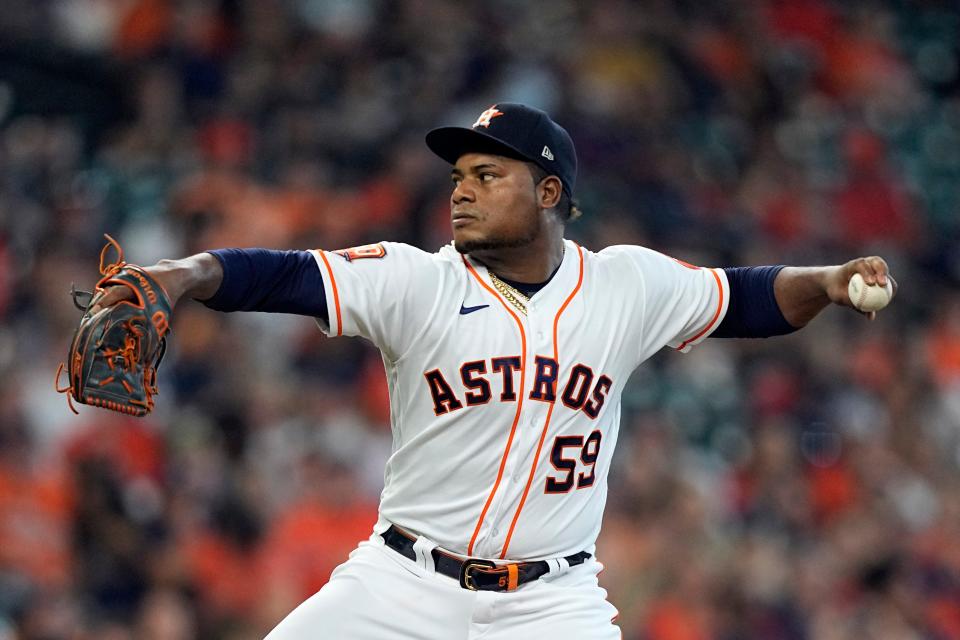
[[94, 103, 892, 640]]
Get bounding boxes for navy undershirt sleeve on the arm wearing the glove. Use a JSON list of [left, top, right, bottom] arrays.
[[203, 249, 330, 322]]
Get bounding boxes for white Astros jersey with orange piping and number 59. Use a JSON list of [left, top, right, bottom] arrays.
[[314, 240, 729, 560]]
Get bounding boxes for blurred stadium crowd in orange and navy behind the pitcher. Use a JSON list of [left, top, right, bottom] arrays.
[[0, 0, 960, 640]]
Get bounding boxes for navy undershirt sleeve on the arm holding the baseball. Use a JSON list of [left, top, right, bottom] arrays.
[[710, 265, 797, 338]]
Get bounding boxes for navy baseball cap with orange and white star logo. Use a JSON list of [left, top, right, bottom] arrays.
[[427, 102, 577, 198]]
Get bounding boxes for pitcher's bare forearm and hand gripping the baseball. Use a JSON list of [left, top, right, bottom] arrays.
[[773, 256, 897, 328]]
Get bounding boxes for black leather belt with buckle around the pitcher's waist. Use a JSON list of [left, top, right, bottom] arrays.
[[380, 525, 590, 591]]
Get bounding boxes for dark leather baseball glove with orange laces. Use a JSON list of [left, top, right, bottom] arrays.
[[57, 236, 171, 416]]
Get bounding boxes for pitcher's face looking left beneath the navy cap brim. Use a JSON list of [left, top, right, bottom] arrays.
[[450, 153, 543, 253]]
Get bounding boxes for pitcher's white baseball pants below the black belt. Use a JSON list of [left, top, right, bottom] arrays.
[[266, 535, 621, 640]]
